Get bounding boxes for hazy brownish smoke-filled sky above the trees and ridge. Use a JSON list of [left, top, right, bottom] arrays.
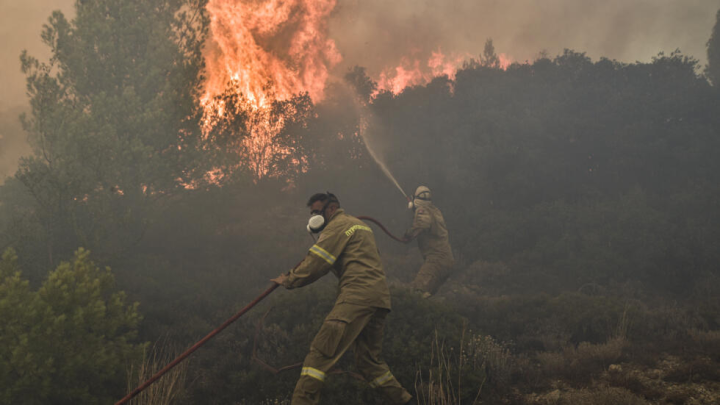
[[0, 0, 720, 108]]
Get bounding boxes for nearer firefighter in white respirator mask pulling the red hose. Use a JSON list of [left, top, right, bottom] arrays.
[[272, 193, 412, 405]]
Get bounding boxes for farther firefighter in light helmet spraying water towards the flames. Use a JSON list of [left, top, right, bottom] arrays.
[[405, 186, 455, 298]]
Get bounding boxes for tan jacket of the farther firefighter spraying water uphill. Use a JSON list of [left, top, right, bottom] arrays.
[[405, 202, 455, 264]]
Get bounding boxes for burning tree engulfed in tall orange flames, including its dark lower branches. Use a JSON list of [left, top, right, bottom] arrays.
[[201, 0, 341, 181]]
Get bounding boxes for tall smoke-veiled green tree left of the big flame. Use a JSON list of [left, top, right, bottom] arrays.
[[0, 0, 207, 272]]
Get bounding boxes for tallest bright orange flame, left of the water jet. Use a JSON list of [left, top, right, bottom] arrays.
[[201, 0, 342, 177]]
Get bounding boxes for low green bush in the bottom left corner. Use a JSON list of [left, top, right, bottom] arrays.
[[0, 249, 143, 404]]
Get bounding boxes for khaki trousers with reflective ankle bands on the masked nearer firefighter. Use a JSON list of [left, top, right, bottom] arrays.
[[292, 303, 412, 405]]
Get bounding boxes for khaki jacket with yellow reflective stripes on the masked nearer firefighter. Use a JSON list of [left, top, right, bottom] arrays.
[[283, 209, 390, 309]]
